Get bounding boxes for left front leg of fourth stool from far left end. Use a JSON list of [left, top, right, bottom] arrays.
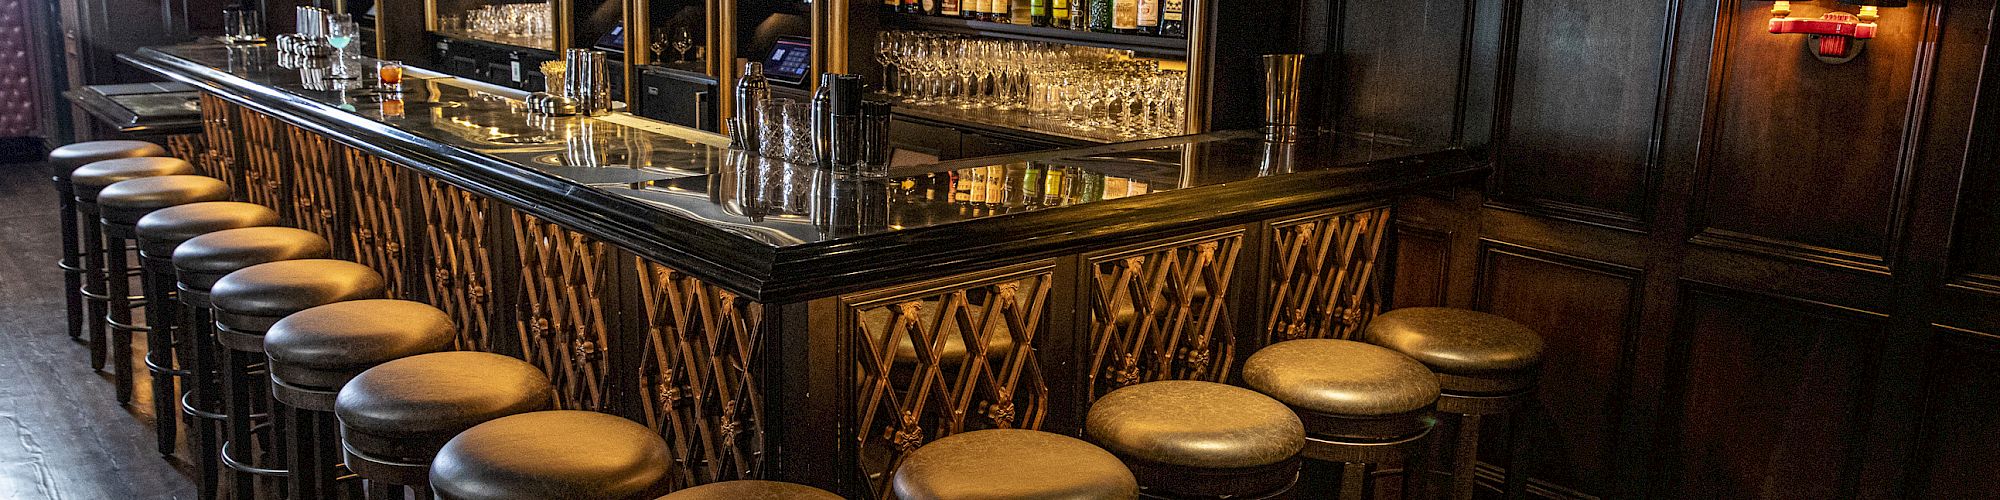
[[140, 258, 186, 454]]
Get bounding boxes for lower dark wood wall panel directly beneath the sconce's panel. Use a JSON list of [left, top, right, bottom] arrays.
[[1658, 284, 1882, 498]]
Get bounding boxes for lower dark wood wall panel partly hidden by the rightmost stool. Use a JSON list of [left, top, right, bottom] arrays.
[[1478, 242, 1640, 492]]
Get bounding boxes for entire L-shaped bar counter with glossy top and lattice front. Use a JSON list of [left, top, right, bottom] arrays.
[[122, 44, 1486, 498]]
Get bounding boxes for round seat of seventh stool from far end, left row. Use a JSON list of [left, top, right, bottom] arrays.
[[264, 298, 456, 388]]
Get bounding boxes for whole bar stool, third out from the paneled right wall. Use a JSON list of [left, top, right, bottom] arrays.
[[1084, 380, 1306, 498]]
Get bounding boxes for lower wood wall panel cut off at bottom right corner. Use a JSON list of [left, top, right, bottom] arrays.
[[1912, 328, 2000, 498]]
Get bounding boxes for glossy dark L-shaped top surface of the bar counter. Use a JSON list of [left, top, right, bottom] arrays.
[[122, 44, 1486, 304]]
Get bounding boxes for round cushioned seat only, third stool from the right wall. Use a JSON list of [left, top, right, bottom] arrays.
[[1084, 380, 1306, 468]]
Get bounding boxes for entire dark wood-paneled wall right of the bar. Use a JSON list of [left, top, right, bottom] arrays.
[[1330, 0, 2000, 498]]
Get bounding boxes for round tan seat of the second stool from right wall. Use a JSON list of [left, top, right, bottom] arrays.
[[1244, 338, 1438, 416]]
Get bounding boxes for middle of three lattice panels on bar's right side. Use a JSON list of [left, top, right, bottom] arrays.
[[1088, 232, 1244, 398]]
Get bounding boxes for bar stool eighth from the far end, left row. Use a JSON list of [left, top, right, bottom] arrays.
[[334, 352, 556, 500]]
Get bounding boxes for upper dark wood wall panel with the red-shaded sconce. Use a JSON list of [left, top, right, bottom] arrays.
[[1698, 2, 1928, 266]]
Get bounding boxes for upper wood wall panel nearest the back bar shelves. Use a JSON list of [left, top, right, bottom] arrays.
[[1338, 0, 1474, 146]]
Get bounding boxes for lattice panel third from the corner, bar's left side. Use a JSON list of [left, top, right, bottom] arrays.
[[412, 178, 494, 352]]
